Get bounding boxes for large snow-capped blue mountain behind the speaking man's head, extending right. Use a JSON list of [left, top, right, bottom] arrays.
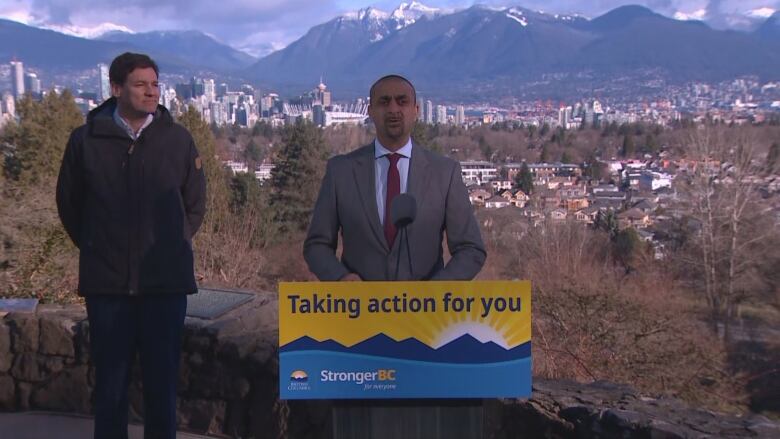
[[250, 3, 780, 94]]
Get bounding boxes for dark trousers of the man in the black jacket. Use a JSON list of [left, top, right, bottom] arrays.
[[87, 294, 187, 439]]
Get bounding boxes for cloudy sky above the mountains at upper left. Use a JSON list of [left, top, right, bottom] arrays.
[[0, 0, 338, 55]]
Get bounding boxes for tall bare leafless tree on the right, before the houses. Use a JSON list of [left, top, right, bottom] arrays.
[[680, 126, 776, 338]]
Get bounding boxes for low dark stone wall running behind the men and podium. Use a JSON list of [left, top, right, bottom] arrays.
[[0, 295, 780, 439]]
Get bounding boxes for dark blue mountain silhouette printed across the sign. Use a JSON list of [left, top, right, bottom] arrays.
[[280, 333, 531, 364]]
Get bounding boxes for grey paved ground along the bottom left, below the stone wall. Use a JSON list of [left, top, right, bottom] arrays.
[[0, 412, 213, 439]]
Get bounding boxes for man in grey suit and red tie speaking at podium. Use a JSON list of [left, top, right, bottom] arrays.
[[303, 75, 485, 281]]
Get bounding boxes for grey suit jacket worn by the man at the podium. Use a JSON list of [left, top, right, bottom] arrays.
[[303, 142, 486, 281]]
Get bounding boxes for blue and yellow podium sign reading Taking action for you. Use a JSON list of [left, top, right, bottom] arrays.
[[279, 281, 531, 399]]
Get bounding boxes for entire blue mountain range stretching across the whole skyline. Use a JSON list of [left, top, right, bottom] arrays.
[[0, 2, 780, 97]]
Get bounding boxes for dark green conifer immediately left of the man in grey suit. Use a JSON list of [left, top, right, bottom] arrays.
[[269, 120, 328, 235]]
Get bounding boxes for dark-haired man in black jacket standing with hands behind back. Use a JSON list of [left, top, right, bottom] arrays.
[[57, 53, 206, 439]]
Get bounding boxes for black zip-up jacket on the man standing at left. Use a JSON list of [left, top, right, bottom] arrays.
[[57, 98, 206, 296]]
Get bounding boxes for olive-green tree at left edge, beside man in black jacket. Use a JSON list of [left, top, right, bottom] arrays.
[[0, 90, 84, 184]]
